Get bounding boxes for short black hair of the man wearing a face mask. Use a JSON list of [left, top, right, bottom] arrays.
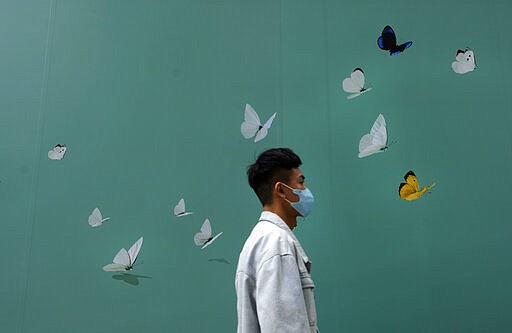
[[247, 148, 302, 205]]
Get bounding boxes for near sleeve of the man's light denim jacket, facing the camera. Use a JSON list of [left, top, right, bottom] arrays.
[[255, 254, 311, 333]]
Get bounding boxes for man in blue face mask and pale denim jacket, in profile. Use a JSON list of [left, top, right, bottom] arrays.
[[235, 148, 318, 333]]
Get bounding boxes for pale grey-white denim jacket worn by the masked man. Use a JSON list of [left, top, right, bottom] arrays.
[[235, 211, 318, 333]]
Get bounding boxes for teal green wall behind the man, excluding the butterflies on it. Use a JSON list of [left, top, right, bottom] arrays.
[[0, 0, 512, 333]]
